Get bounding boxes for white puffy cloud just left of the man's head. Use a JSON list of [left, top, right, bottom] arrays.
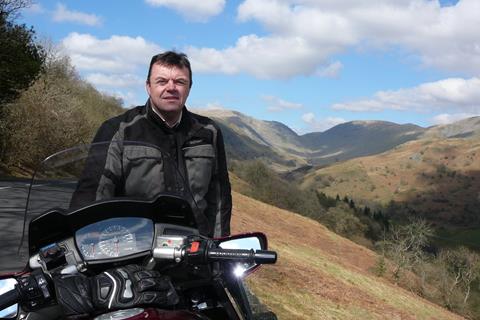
[[62, 32, 162, 73]]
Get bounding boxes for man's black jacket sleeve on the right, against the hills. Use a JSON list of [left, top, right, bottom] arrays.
[[206, 126, 232, 238]]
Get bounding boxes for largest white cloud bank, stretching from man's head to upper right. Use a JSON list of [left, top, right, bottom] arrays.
[[189, 0, 480, 79]]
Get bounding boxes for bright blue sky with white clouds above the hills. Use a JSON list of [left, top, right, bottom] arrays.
[[20, 0, 480, 134]]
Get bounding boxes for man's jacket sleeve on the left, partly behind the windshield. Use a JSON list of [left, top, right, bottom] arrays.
[[70, 121, 121, 208]]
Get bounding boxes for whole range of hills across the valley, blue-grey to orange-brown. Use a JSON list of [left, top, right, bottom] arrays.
[[196, 110, 480, 231]]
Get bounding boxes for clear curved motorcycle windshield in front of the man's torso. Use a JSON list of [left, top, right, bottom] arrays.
[[0, 141, 201, 272]]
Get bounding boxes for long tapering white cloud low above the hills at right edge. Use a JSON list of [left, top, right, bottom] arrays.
[[332, 77, 480, 113]]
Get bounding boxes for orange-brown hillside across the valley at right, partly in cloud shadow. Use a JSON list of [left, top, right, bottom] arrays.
[[302, 117, 480, 227]]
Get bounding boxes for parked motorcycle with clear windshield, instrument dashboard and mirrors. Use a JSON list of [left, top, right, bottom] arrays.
[[0, 141, 277, 320]]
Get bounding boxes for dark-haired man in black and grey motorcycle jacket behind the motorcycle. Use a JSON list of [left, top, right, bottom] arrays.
[[72, 51, 232, 237]]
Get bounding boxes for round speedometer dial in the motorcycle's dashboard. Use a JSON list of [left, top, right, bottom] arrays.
[[98, 225, 136, 258]]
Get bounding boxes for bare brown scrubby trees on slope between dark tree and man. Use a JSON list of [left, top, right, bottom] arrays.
[[3, 54, 122, 170]]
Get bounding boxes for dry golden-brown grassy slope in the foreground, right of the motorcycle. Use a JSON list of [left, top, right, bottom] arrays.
[[232, 192, 461, 320]]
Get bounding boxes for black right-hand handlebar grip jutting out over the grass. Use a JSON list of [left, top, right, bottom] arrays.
[[207, 248, 277, 264]]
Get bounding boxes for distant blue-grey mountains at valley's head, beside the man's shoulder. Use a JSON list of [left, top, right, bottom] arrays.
[[195, 109, 426, 171]]
